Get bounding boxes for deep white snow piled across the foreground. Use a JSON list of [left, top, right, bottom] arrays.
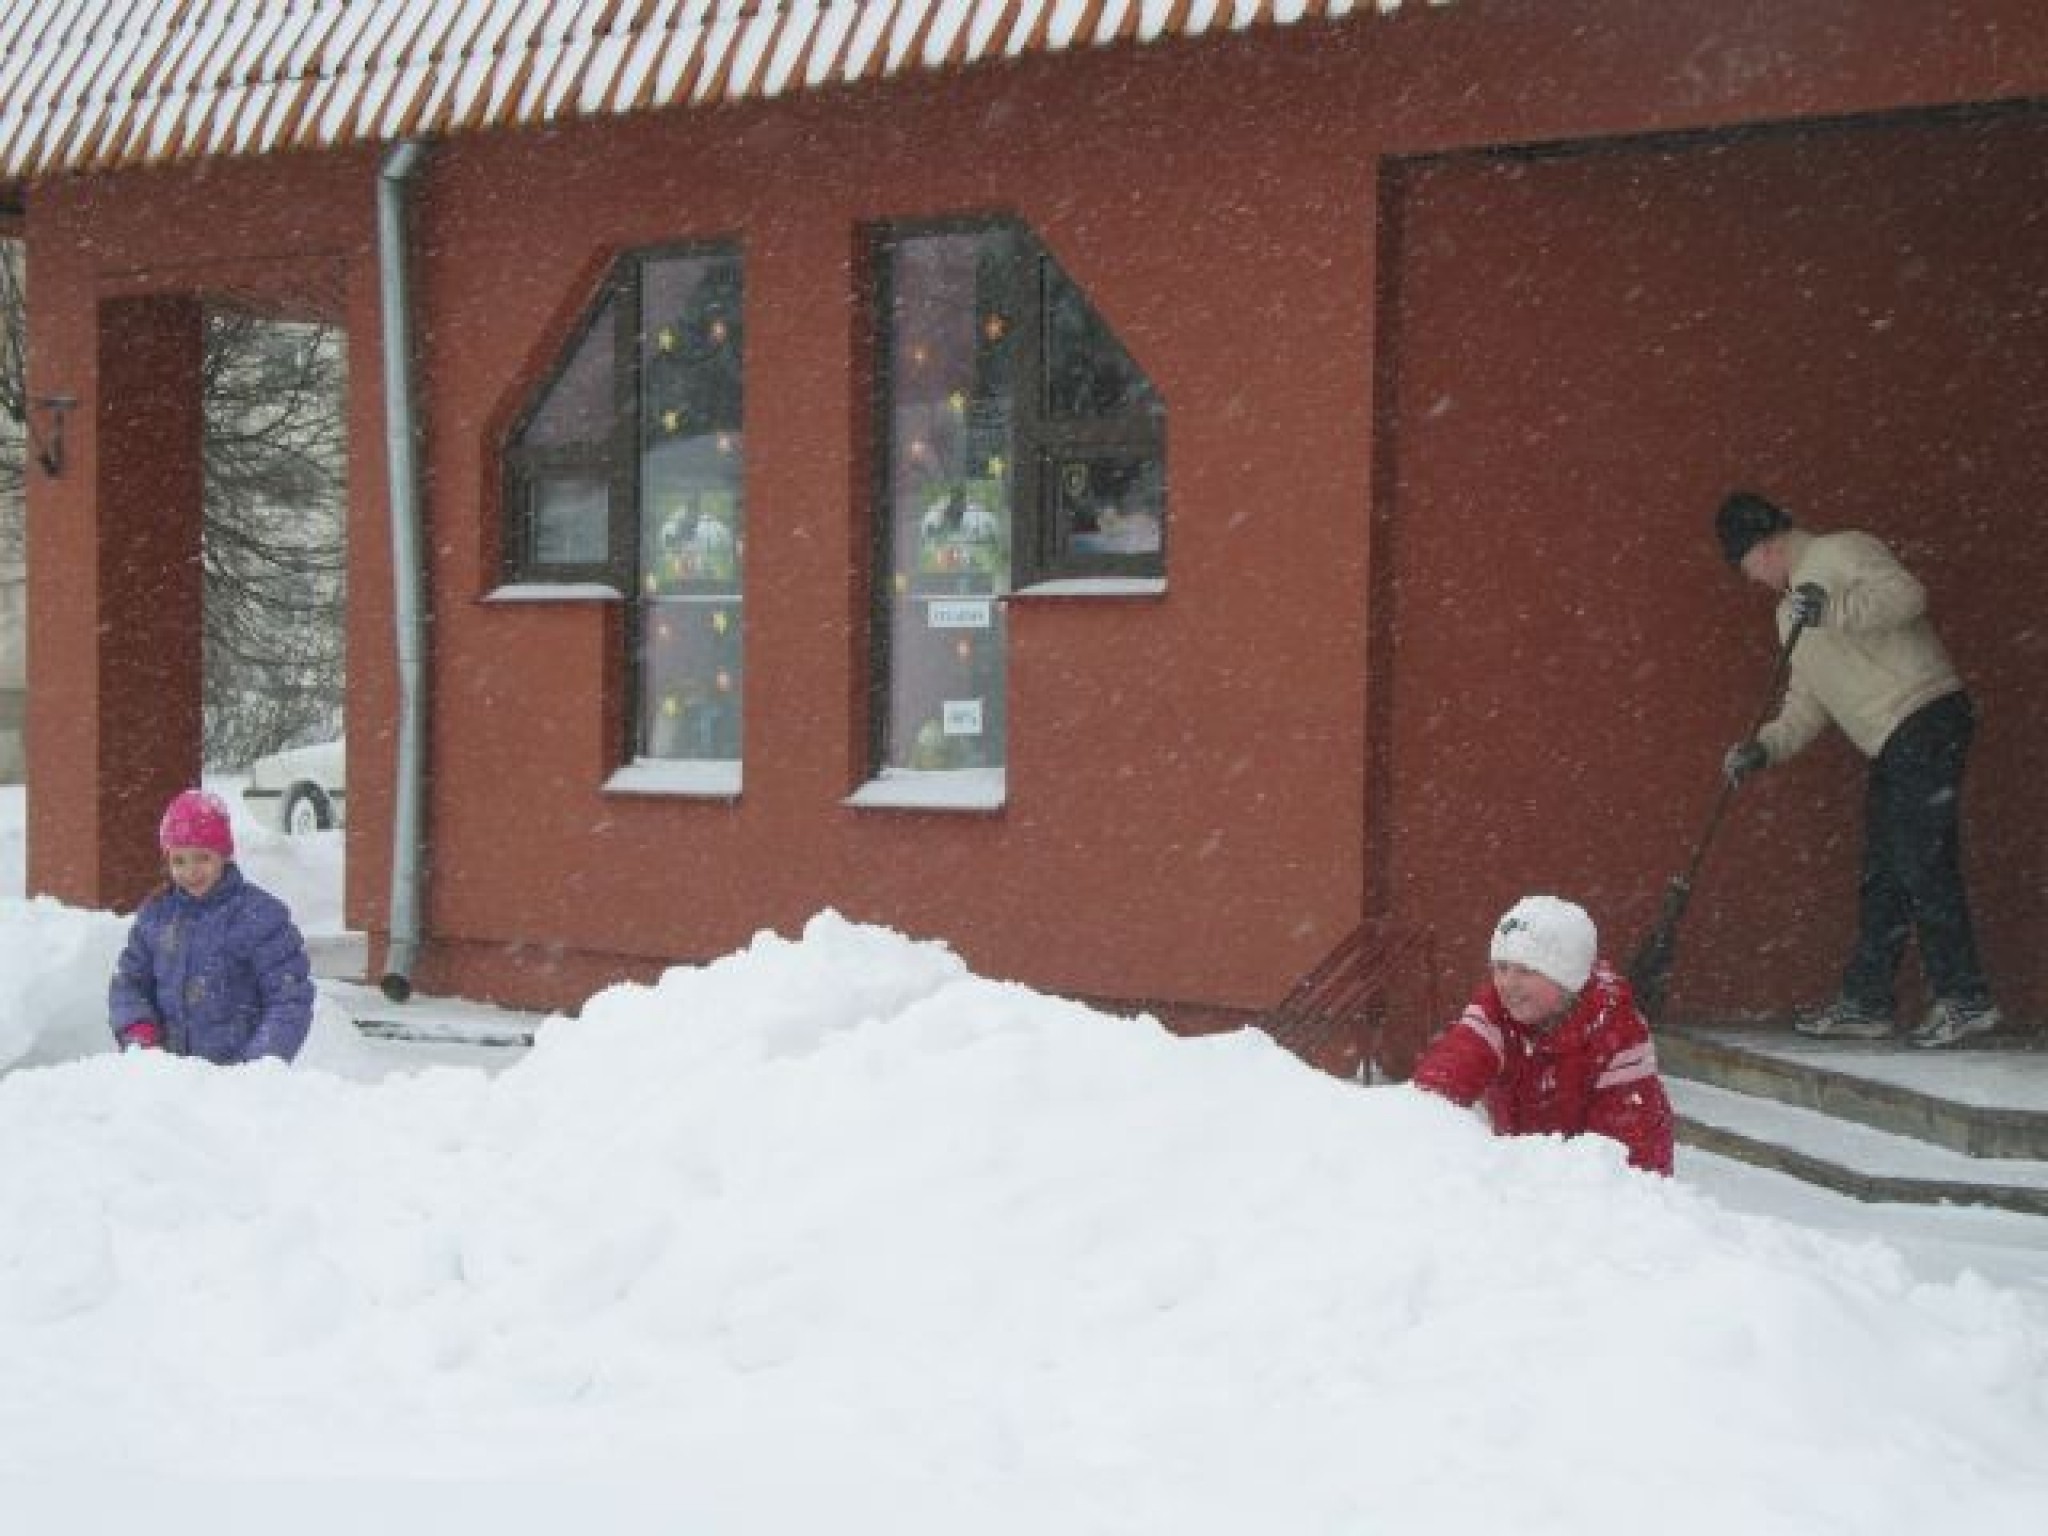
[[0, 791, 2048, 1536]]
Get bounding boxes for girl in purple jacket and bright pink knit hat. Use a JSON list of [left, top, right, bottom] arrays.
[[109, 788, 313, 1063]]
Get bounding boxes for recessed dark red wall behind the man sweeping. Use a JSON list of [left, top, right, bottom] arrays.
[[1389, 113, 2048, 1028]]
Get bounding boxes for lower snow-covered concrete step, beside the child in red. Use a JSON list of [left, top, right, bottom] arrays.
[[1665, 1075, 2048, 1239]]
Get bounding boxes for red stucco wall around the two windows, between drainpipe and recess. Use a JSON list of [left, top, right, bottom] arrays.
[[378, 45, 1372, 1004]]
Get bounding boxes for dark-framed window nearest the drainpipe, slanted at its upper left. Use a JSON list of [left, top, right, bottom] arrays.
[[504, 248, 745, 788]]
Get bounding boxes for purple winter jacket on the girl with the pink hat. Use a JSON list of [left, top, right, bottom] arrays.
[[106, 864, 313, 1065]]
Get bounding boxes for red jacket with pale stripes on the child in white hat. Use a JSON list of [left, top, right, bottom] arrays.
[[1415, 961, 1671, 1174]]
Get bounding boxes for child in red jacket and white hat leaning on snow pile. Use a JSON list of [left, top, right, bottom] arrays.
[[1415, 895, 1671, 1174]]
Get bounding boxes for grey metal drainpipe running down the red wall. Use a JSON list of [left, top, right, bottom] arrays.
[[377, 139, 426, 1004]]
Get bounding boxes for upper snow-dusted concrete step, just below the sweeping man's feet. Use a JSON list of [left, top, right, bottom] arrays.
[[1657, 1028, 2048, 1161]]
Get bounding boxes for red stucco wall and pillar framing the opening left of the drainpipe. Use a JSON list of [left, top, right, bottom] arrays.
[[27, 156, 389, 907]]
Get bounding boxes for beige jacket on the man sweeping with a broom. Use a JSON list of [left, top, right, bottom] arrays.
[[1757, 528, 1962, 762]]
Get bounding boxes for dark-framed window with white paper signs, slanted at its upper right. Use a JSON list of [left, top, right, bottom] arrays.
[[864, 221, 1165, 805]]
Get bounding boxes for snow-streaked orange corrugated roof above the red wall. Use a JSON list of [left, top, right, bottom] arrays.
[[0, 0, 1448, 180]]
